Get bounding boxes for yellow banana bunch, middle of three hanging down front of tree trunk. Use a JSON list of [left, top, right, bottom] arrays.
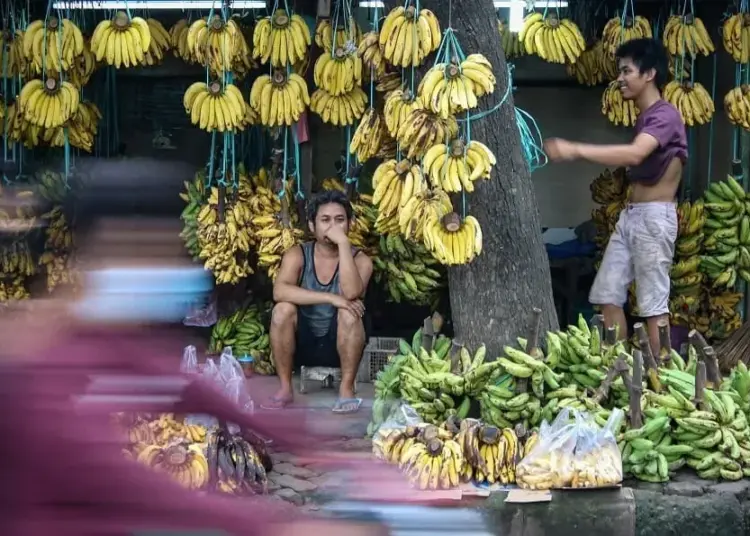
[[422, 140, 497, 193]]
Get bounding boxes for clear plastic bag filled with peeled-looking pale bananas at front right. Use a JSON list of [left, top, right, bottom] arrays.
[[516, 408, 623, 490]]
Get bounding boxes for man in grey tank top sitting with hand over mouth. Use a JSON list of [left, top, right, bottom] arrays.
[[262, 190, 372, 413]]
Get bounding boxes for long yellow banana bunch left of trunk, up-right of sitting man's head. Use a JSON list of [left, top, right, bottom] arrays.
[[372, 159, 427, 233]]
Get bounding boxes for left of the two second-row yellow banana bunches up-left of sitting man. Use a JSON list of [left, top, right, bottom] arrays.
[[182, 81, 247, 132]]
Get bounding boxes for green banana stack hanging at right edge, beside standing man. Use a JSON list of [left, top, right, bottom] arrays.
[[701, 176, 750, 290]]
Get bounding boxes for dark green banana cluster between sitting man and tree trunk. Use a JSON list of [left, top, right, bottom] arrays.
[[373, 233, 446, 309]]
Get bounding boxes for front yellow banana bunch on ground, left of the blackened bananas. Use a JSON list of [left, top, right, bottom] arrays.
[[137, 443, 210, 489]]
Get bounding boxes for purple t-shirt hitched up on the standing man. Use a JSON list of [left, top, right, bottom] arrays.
[[629, 100, 687, 185]]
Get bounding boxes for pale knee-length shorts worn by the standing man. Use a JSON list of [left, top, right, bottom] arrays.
[[589, 203, 677, 318]]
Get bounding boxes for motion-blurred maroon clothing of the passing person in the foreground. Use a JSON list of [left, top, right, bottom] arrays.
[[0, 326, 308, 536]]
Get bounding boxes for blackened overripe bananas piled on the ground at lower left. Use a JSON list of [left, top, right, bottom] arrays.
[[206, 429, 273, 495]]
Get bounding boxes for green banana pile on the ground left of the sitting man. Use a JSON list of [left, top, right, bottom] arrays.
[[209, 304, 275, 374]]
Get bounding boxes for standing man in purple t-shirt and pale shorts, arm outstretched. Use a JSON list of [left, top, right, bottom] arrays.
[[544, 39, 687, 351]]
